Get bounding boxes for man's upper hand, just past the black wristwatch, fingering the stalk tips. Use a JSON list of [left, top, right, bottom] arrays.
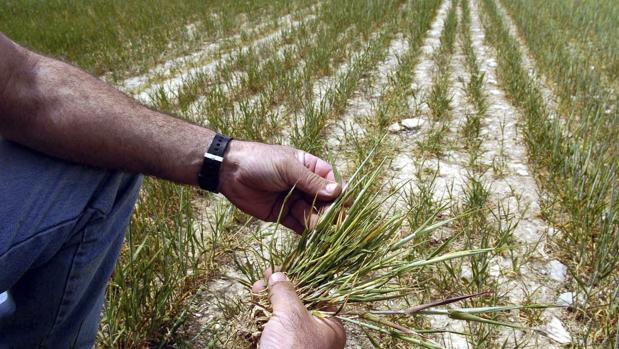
[[219, 140, 342, 233]]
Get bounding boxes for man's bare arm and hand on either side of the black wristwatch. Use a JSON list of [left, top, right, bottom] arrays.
[[0, 34, 342, 233]]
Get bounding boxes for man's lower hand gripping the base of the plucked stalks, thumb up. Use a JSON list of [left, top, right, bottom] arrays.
[[252, 271, 346, 349]]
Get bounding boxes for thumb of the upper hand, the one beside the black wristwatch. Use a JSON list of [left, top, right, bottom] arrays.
[[288, 162, 342, 201]]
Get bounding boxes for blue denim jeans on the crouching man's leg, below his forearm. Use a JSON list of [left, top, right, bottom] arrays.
[[0, 139, 142, 349]]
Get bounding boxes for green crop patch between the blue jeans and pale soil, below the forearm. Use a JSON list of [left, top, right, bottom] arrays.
[[98, 179, 205, 348]]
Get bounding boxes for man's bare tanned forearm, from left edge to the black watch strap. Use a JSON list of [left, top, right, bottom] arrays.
[[0, 34, 214, 185]]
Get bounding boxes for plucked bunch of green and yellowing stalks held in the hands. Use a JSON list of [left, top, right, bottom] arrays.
[[237, 147, 547, 348]]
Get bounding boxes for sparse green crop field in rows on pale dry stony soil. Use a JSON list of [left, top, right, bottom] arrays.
[[7, 0, 619, 349]]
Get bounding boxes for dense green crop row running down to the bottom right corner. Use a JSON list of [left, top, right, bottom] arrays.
[[482, 0, 619, 347]]
